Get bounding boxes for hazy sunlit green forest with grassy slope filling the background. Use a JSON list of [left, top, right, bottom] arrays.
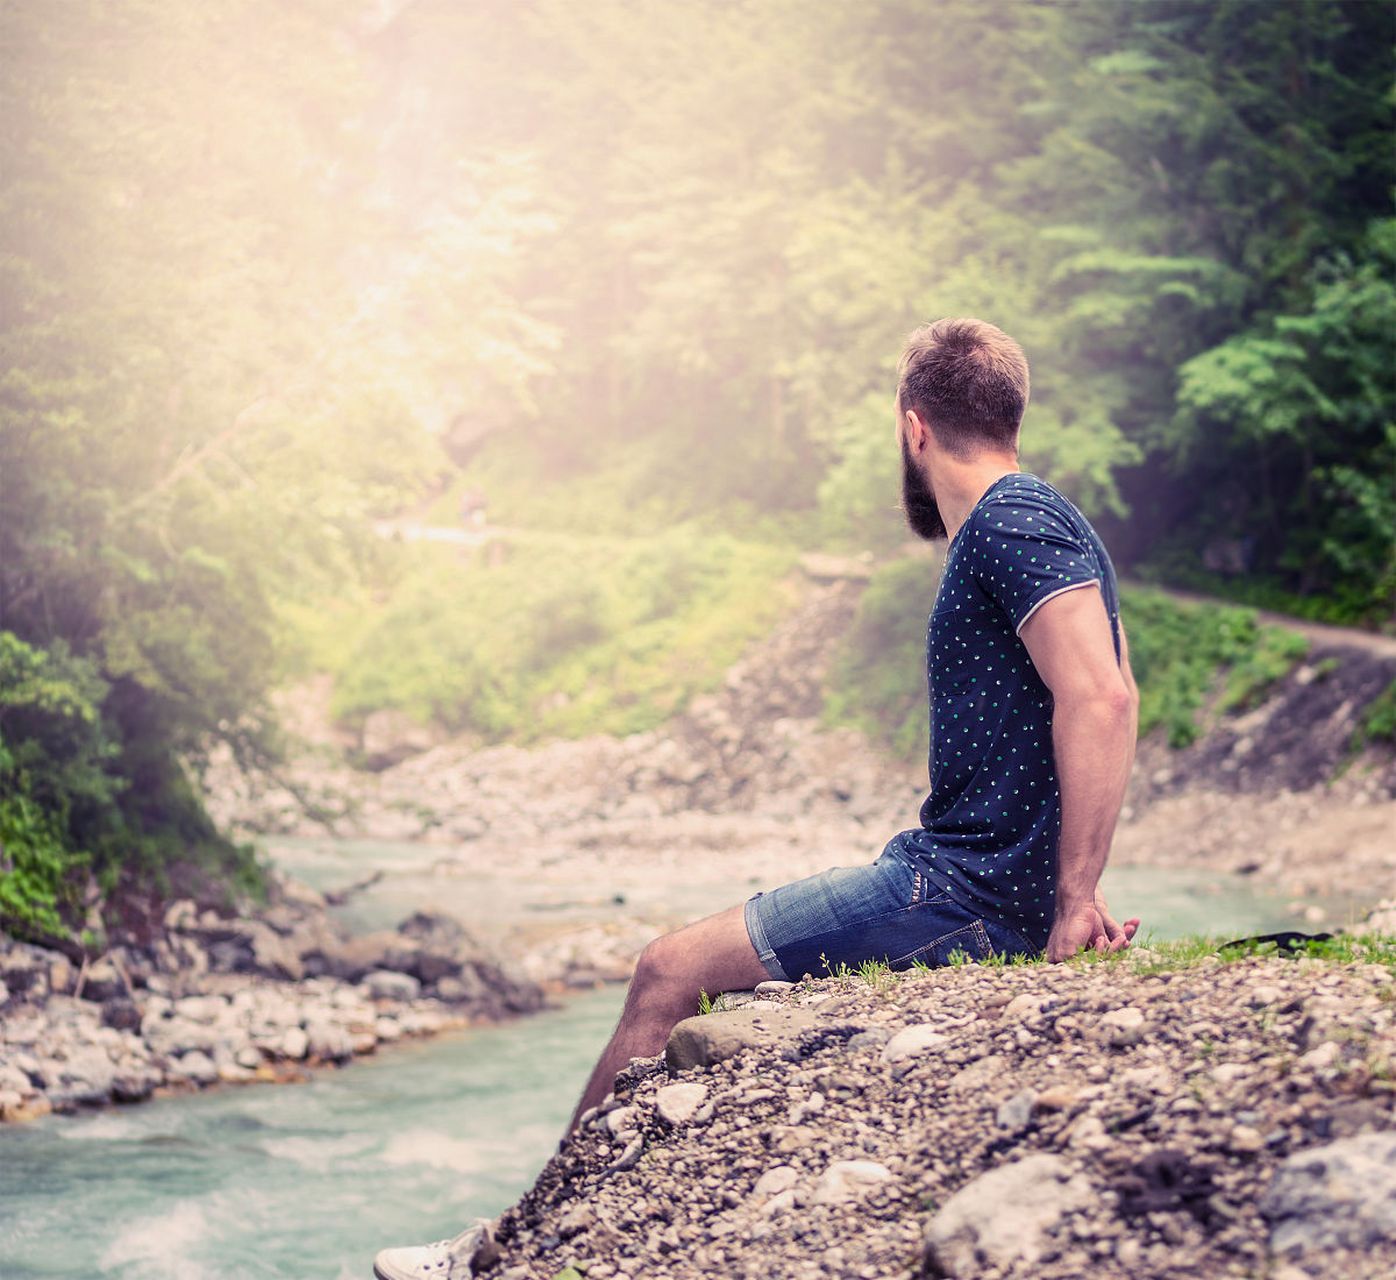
[[0, 0, 1396, 938]]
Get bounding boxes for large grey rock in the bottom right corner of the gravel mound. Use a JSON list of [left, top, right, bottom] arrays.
[[1261, 1131, 1396, 1252]]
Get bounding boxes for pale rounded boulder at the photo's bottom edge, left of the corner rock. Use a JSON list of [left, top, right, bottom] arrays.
[[924, 1153, 1099, 1280]]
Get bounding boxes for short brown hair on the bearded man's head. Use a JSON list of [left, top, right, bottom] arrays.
[[896, 320, 1027, 456]]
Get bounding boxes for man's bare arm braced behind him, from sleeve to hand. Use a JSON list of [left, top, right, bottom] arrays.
[[1019, 586, 1139, 960]]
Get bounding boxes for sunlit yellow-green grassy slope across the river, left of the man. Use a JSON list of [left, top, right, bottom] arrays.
[[283, 528, 796, 743]]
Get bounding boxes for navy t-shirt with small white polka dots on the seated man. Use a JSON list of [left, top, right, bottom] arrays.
[[895, 472, 1120, 946]]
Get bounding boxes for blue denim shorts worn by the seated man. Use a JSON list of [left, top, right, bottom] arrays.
[[744, 842, 1041, 981]]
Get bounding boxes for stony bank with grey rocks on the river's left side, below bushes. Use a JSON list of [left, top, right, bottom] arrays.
[[0, 879, 543, 1121]]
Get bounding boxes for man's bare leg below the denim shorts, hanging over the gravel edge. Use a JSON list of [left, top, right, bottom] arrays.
[[567, 905, 771, 1133]]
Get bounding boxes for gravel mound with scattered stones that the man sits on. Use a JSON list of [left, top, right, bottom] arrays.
[[471, 938, 1396, 1280]]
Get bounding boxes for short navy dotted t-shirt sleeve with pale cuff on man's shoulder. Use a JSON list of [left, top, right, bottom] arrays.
[[970, 496, 1100, 632]]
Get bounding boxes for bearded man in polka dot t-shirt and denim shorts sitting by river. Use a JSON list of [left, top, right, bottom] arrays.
[[377, 312, 1139, 1280]]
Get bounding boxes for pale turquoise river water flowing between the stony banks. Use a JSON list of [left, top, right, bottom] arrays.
[[0, 842, 1351, 1280]]
